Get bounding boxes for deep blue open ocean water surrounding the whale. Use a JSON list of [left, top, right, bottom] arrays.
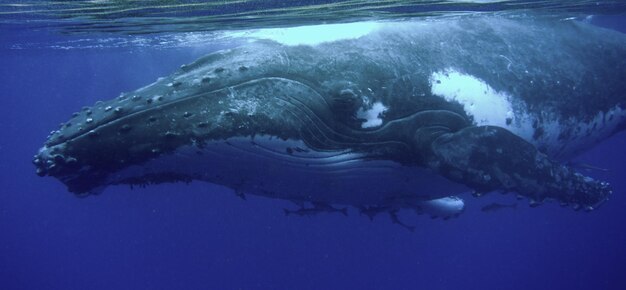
[[0, 2, 626, 289]]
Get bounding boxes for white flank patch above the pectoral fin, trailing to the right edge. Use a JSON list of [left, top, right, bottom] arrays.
[[430, 68, 626, 158]]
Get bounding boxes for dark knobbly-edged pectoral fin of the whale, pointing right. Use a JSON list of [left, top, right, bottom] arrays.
[[429, 126, 611, 209]]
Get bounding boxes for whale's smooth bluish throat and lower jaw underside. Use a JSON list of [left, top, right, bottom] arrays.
[[106, 135, 467, 215]]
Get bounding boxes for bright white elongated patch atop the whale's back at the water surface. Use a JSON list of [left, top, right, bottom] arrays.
[[228, 22, 381, 46]]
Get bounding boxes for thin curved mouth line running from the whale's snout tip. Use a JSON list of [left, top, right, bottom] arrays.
[[44, 76, 312, 148]]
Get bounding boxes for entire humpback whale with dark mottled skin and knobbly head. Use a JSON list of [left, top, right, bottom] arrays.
[[34, 17, 626, 215]]
